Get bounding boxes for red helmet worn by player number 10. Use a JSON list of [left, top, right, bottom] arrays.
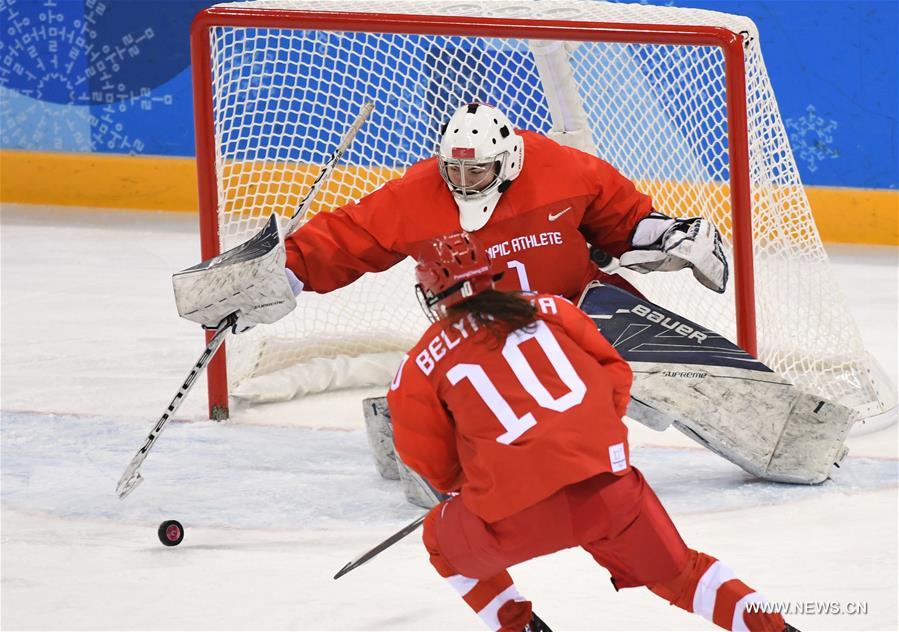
[[415, 233, 499, 321]]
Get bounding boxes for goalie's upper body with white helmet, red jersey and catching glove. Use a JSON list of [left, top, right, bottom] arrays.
[[278, 103, 728, 308]]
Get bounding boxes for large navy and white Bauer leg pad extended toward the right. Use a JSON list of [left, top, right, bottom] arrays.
[[579, 284, 856, 483]]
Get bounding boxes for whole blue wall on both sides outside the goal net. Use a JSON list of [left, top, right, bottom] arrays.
[[0, 0, 899, 189]]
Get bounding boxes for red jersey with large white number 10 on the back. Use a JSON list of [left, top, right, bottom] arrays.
[[387, 294, 632, 522]]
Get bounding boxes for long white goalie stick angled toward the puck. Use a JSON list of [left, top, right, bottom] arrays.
[[116, 101, 375, 500]]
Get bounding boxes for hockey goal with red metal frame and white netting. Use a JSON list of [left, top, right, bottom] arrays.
[[191, 0, 895, 417]]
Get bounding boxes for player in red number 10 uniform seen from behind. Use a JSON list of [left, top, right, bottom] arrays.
[[388, 233, 792, 632]]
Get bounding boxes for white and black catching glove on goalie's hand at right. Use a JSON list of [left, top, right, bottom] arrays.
[[618, 211, 728, 294]]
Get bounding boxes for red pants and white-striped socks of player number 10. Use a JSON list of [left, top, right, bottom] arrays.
[[423, 469, 784, 632]]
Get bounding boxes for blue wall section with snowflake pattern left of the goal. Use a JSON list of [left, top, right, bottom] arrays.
[[0, 0, 205, 156]]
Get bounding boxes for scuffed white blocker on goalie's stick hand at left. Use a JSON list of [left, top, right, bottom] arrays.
[[172, 215, 303, 333]]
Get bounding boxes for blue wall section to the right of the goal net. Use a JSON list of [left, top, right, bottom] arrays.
[[644, 0, 899, 189]]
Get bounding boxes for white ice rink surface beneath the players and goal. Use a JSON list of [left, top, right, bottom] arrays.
[[0, 205, 899, 630]]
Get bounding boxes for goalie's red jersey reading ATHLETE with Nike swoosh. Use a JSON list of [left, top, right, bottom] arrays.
[[286, 132, 652, 299]]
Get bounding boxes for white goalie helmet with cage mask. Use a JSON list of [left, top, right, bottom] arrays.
[[438, 103, 524, 231]]
